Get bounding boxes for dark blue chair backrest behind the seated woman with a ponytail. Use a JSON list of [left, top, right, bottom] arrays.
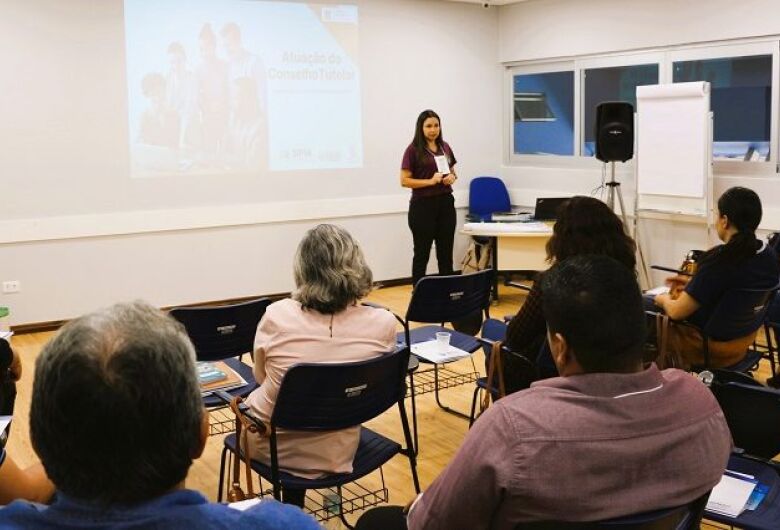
[[702, 286, 777, 341]]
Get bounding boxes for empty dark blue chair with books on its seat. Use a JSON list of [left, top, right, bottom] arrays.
[[170, 298, 271, 434]]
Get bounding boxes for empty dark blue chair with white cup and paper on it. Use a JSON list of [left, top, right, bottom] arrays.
[[397, 269, 493, 451]]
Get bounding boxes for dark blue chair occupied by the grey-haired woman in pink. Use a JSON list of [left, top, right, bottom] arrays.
[[213, 348, 420, 524]]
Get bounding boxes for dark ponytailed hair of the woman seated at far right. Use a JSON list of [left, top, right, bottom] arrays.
[[699, 186, 763, 268]]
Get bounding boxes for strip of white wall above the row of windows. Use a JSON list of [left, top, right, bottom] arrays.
[[499, 0, 780, 63]]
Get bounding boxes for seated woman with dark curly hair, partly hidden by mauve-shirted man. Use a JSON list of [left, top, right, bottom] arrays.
[[504, 196, 636, 386]]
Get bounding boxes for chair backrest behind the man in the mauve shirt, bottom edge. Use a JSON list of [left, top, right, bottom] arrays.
[[515, 492, 710, 530]]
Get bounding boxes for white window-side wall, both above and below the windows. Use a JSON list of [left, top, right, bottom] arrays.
[[499, 0, 780, 281]]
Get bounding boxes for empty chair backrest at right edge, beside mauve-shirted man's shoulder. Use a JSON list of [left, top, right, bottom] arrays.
[[710, 370, 780, 459]]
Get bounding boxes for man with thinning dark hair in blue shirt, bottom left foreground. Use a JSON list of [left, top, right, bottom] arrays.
[[0, 302, 320, 530]]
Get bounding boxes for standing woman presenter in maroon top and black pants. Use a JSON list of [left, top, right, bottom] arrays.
[[401, 110, 458, 285]]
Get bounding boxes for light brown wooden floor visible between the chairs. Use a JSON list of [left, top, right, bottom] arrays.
[[7, 280, 769, 528]]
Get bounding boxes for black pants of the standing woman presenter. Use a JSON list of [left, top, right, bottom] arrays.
[[409, 193, 455, 285]]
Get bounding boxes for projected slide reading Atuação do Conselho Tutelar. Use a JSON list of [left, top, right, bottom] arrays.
[[124, 0, 363, 177]]
